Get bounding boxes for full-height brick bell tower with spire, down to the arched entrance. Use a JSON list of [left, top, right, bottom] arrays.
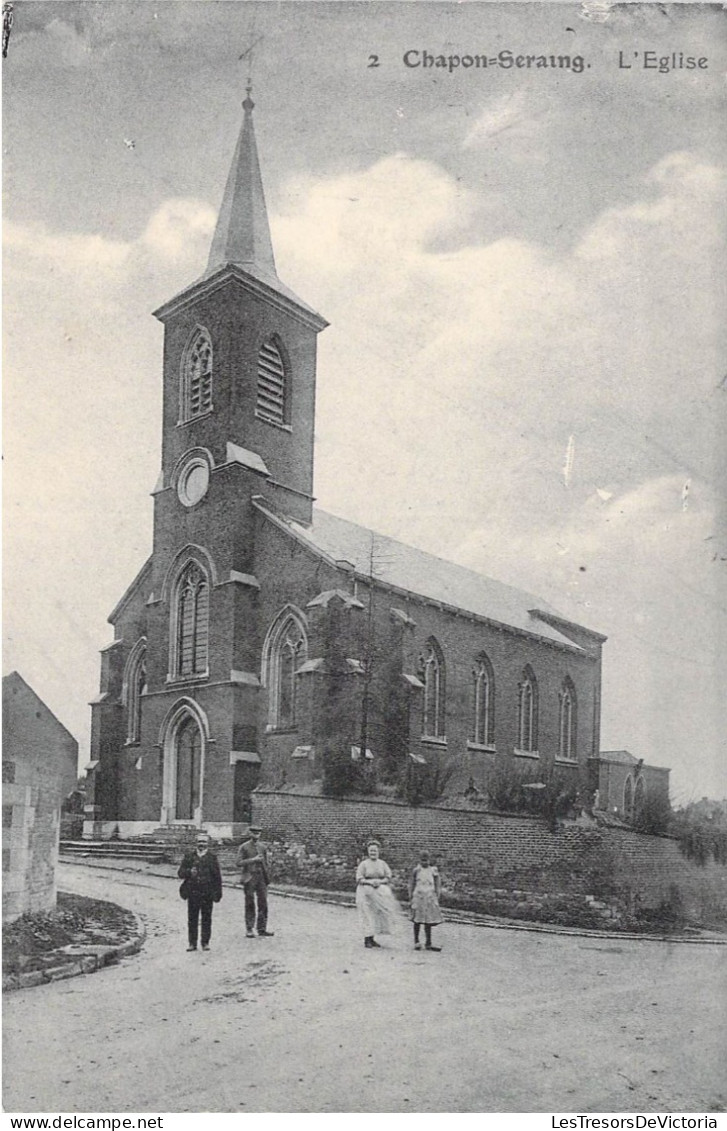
[[138, 87, 327, 791]]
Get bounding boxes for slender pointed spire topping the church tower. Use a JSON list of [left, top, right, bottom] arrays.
[[206, 79, 277, 279]]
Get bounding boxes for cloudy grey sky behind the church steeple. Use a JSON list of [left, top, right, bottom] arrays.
[[2, 0, 727, 804]]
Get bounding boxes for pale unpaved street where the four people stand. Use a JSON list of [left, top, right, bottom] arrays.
[[5, 865, 727, 1114]]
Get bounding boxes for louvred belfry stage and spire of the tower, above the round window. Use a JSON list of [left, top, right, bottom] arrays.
[[150, 84, 328, 523]]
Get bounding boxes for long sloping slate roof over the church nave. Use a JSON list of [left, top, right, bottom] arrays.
[[258, 501, 583, 651]]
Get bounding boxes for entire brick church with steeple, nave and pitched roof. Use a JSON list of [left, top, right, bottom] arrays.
[[84, 89, 605, 837]]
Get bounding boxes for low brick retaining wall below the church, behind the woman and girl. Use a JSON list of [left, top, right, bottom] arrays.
[[253, 791, 727, 925]]
